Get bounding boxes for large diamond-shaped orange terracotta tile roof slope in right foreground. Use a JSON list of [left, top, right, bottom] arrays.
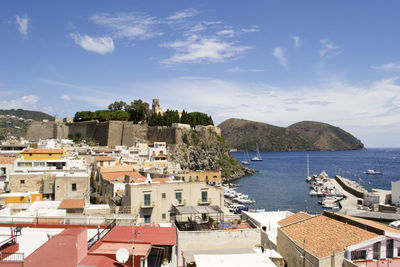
[[281, 215, 378, 258]]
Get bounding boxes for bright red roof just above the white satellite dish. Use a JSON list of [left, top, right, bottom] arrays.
[[102, 225, 176, 246]]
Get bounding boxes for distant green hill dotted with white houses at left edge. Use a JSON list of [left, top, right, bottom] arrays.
[[0, 109, 54, 140]]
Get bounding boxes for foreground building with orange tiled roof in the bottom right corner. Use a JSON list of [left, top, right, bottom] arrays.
[[277, 211, 400, 266]]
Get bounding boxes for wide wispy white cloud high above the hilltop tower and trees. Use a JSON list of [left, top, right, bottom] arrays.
[[161, 34, 252, 64]]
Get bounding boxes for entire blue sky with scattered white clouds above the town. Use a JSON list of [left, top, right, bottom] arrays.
[[0, 0, 400, 147]]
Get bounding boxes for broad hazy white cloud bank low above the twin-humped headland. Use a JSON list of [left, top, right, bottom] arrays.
[[144, 78, 400, 145]]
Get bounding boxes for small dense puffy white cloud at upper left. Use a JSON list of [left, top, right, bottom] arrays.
[[70, 33, 114, 55]]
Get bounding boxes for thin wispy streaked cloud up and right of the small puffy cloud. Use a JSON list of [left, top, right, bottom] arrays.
[[90, 13, 162, 40]]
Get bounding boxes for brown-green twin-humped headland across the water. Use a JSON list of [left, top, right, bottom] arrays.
[[218, 119, 364, 151]]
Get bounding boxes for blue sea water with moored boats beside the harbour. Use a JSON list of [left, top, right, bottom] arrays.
[[231, 148, 400, 214]]
